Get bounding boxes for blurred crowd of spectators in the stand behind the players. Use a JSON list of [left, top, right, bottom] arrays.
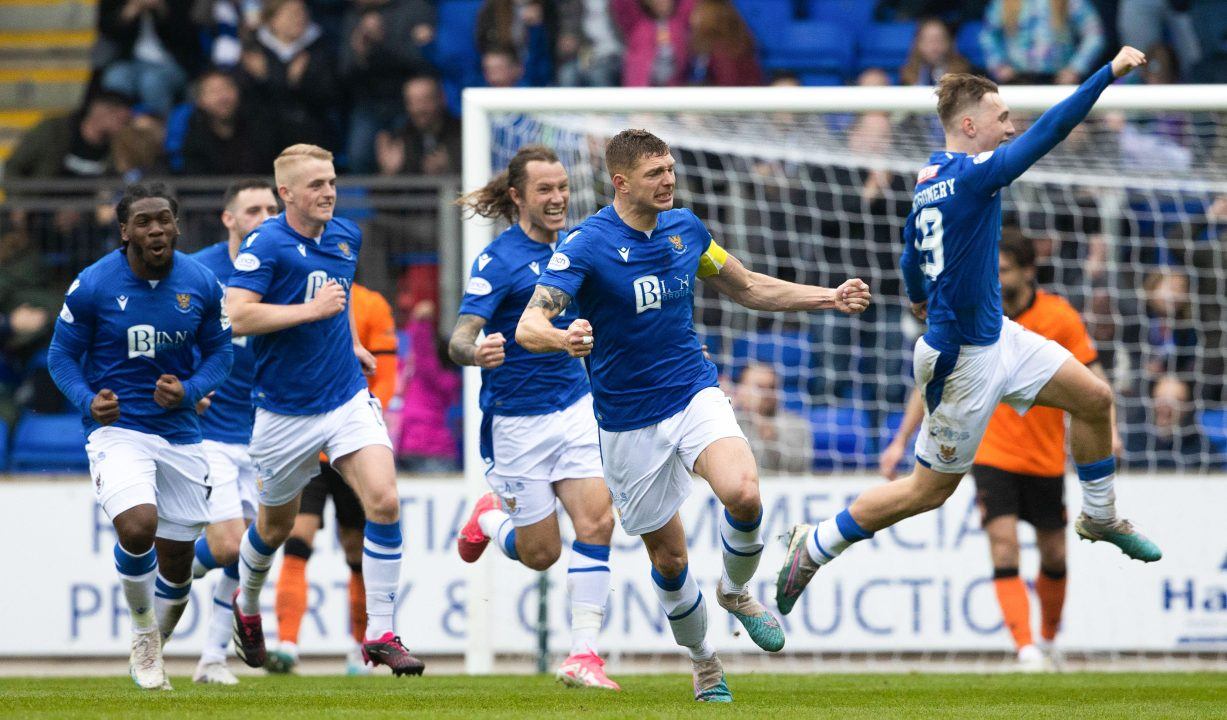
[[0, 0, 1227, 472]]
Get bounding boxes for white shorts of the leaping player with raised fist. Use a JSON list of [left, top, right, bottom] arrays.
[[912, 318, 1074, 473]]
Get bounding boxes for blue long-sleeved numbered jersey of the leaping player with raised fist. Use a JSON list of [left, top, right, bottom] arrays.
[[901, 65, 1113, 352]]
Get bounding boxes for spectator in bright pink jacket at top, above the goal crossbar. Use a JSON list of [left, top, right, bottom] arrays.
[[610, 0, 696, 87]]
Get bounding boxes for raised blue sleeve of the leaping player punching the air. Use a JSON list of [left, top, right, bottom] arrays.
[[962, 65, 1115, 195]]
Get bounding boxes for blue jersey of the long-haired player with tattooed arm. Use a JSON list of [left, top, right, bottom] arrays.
[[460, 224, 588, 415]]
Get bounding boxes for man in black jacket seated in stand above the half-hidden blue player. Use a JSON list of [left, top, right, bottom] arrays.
[[180, 70, 281, 175]]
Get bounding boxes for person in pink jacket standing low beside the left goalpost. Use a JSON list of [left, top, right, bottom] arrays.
[[396, 301, 460, 472]]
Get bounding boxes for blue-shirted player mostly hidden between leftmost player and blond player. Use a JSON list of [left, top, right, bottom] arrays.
[[191, 179, 277, 684]]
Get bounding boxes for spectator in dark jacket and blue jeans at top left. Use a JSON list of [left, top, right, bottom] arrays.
[[98, 0, 202, 115]]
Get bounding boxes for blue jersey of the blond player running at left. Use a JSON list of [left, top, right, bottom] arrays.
[[228, 213, 367, 415]]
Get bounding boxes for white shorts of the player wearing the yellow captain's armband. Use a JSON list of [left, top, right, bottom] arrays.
[[600, 388, 746, 535]]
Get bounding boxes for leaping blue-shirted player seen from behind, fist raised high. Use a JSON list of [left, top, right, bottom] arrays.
[[775, 47, 1162, 613]]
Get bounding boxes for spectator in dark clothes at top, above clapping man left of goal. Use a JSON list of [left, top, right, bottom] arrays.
[[340, 0, 436, 173]]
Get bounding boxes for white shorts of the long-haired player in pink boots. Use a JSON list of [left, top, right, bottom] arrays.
[[482, 395, 601, 527]]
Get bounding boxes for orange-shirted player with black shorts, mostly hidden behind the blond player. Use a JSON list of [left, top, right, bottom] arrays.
[[265, 283, 396, 675]]
